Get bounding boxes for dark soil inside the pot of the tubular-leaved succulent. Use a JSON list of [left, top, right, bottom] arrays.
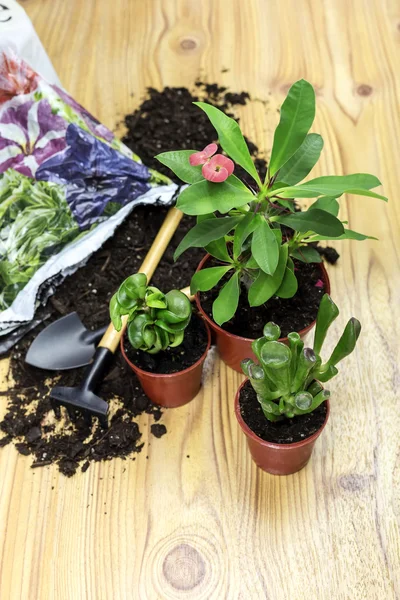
[[239, 381, 327, 444]]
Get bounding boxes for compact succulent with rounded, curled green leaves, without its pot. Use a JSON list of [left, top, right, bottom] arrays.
[[110, 273, 192, 354]]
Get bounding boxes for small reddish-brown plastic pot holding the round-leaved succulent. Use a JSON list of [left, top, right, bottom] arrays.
[[121, 323, 211, 408]]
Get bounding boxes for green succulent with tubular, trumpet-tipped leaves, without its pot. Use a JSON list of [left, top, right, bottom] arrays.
[[242, 294, 361, 421]]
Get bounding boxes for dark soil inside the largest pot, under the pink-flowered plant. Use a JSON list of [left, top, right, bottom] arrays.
[[200, 258, 325, 339]]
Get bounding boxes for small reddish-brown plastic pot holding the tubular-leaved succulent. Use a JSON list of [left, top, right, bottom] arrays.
[[235, 379, 330, 475]]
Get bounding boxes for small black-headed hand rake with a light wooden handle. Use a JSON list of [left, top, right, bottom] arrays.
[[44, 208, 182, 427]]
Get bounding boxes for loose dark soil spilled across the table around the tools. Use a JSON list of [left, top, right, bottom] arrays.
[[0, 79, 260, 476]]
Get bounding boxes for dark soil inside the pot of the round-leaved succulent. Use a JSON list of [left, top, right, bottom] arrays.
[[124, 314, 208, 374]]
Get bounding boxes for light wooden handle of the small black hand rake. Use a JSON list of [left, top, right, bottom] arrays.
[[99, 207, 183, 353]]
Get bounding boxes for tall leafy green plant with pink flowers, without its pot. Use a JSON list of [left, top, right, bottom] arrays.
[[157, 79, 387, 325]]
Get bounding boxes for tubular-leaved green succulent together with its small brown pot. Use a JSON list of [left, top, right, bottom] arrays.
[[235, 294, 361, 475]]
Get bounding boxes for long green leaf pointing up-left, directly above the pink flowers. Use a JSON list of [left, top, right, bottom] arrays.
[[194, 102, 262, 187]]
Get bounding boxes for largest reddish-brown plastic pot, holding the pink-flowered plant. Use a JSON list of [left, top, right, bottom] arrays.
[[195, 254, 331, 373]]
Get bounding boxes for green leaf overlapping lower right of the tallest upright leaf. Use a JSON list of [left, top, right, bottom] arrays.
[[279, 133, 324, 185]]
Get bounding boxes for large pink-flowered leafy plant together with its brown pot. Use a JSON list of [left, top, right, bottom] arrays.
[[157, 80, 387, 371]]
